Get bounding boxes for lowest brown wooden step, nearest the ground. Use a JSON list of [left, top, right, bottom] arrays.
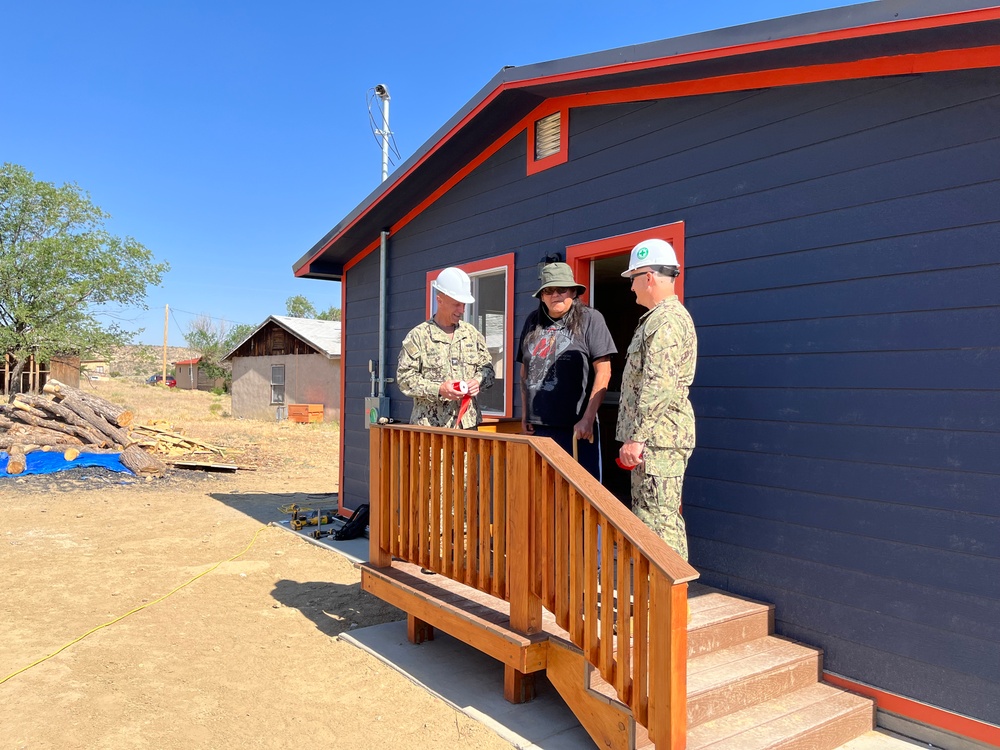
[[688, 683, 875, 750]]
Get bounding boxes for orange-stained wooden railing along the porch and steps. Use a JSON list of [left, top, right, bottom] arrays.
[[369, 424, 698, 750]]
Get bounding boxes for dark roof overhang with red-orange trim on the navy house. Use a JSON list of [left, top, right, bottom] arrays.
[[292, 0, 1000, 280]]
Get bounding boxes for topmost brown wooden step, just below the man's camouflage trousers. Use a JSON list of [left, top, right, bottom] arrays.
[[688, 584, 774, 658]]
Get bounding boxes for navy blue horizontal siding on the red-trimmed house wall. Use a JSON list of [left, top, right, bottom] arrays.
[[343, 69, 1000, 723]]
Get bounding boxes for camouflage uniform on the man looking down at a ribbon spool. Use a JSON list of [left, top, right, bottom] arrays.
[[396, 318, 494, 429]]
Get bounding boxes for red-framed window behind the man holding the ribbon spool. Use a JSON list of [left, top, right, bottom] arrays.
[[427, 253, 514, 417]]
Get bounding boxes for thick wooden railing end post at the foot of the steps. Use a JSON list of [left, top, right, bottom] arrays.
[[649, 571, 688, 750]]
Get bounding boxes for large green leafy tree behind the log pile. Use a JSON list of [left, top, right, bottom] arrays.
[[0, 163, 170, 393]]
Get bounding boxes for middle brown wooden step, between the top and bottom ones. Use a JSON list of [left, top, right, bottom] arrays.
[[688, 636, 822, 728]]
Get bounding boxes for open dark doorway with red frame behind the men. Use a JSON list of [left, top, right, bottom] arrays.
[[566, 221, 684, 507]]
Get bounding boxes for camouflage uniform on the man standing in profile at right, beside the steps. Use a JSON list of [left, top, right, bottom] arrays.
[[615, 297, 697, 560]]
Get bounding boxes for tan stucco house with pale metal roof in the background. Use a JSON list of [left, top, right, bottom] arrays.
[[222, 315, 341, 422]]
